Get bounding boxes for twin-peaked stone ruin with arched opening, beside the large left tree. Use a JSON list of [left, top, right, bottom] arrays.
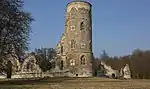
[[0, 54, 42, 78]]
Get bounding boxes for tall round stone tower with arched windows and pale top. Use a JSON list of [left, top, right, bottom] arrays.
[[65, 1, 93, 77]]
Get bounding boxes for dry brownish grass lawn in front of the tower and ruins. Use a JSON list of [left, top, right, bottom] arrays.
[[0, 77, 150, 89]]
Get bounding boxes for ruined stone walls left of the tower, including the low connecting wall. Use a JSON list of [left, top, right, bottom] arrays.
[[0, 51, 79, 79]]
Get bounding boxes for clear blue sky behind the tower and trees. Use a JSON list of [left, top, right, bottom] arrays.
[[24, 0, 150, 57]]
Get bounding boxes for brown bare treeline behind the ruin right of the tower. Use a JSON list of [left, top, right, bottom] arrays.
[[94, 49, 150, 79]]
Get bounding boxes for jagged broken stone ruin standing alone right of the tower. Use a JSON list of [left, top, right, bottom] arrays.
[[101, 61, 131, 79]]
